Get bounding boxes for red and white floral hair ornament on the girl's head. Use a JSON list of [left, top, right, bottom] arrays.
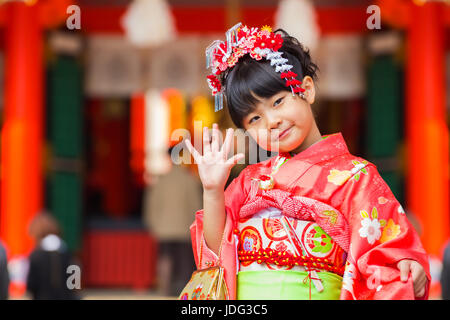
[[205, 23, 305, 111]]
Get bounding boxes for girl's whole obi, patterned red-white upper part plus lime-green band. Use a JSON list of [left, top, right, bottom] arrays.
[[237, 208, 346, 299]]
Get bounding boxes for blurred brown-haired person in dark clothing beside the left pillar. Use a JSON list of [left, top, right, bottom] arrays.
[[27, 213, 78, 300]]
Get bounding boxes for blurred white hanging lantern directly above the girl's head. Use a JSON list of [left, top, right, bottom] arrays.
[[275, 0, 320, 51]]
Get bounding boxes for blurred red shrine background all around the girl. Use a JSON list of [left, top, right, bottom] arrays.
[[0, 0, 450, 299]]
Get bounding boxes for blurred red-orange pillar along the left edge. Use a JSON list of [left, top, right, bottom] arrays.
[[0, 2, 43, 294]]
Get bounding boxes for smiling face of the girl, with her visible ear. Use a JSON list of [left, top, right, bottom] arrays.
[[242, 77, 321, 152]]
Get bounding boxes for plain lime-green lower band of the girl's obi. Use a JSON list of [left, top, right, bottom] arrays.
[[237, 270, 342, 300]]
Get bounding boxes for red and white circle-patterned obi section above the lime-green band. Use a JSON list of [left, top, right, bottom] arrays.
[[238, 208, 347, 276]]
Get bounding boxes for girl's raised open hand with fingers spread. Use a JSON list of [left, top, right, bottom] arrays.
[[186, 123, 245, 191]]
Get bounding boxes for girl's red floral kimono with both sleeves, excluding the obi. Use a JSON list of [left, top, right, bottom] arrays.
[[191, 133, 431, 300]]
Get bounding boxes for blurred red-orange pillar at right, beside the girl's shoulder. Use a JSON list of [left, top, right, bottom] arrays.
[[406, 3, 449, 257]]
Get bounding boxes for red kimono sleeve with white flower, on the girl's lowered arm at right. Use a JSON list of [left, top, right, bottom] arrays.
[[335, 164, 431, 300]]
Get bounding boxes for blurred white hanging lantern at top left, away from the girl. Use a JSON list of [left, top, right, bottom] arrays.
[[121, 0, 176, 48]]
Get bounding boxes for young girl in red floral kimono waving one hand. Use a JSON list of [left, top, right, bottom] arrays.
[[186, 24, 430, 299]]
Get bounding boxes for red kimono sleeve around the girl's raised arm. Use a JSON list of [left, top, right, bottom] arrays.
[[190, 169, 247, 269]]
